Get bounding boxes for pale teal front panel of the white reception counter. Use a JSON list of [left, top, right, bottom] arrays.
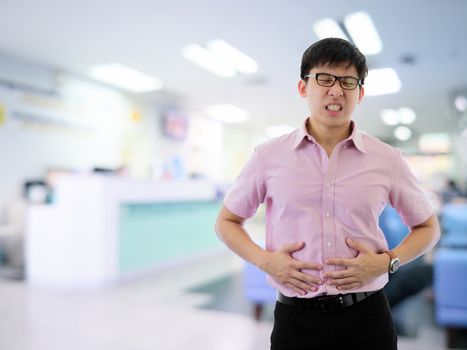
[[119, 202, 222, 273]]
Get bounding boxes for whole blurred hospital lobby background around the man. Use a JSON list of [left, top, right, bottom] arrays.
[[0, 0, 467, 350]]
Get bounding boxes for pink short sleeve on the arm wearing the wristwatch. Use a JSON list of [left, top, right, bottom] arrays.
[[389, 150, 433, 226]]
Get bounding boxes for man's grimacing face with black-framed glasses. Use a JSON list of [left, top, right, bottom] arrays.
[[298, 64, 364, 127]]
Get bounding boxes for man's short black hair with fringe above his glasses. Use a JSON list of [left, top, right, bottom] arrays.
[[300, 38, 368, 84]]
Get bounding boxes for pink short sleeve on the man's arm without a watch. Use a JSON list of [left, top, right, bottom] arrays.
[[224, 149, 266, 219]]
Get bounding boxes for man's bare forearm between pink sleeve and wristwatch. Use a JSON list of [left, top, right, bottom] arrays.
[[394, 215, 440, 264]]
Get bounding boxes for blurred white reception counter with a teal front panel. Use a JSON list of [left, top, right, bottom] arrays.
[[25, 175, 222, 288]]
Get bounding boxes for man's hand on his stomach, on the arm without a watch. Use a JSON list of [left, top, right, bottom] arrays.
[[259, 242, 323, 295]]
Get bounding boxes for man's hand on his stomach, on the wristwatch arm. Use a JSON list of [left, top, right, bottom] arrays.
[[324, 238, 389, 290]]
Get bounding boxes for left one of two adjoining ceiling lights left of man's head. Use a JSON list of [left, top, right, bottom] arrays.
[[182, 44, 237, 78]]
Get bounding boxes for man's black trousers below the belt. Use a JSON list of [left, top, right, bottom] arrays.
[[271, 290, 397, 350]]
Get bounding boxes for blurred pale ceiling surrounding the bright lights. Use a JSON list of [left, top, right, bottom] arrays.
[[0, 0, 467, 140]]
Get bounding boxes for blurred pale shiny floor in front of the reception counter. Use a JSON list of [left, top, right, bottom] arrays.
[[0, 252, 450, 350]]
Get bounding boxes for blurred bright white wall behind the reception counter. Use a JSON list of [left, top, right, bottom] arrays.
[[0, 54, 227, 210]]
